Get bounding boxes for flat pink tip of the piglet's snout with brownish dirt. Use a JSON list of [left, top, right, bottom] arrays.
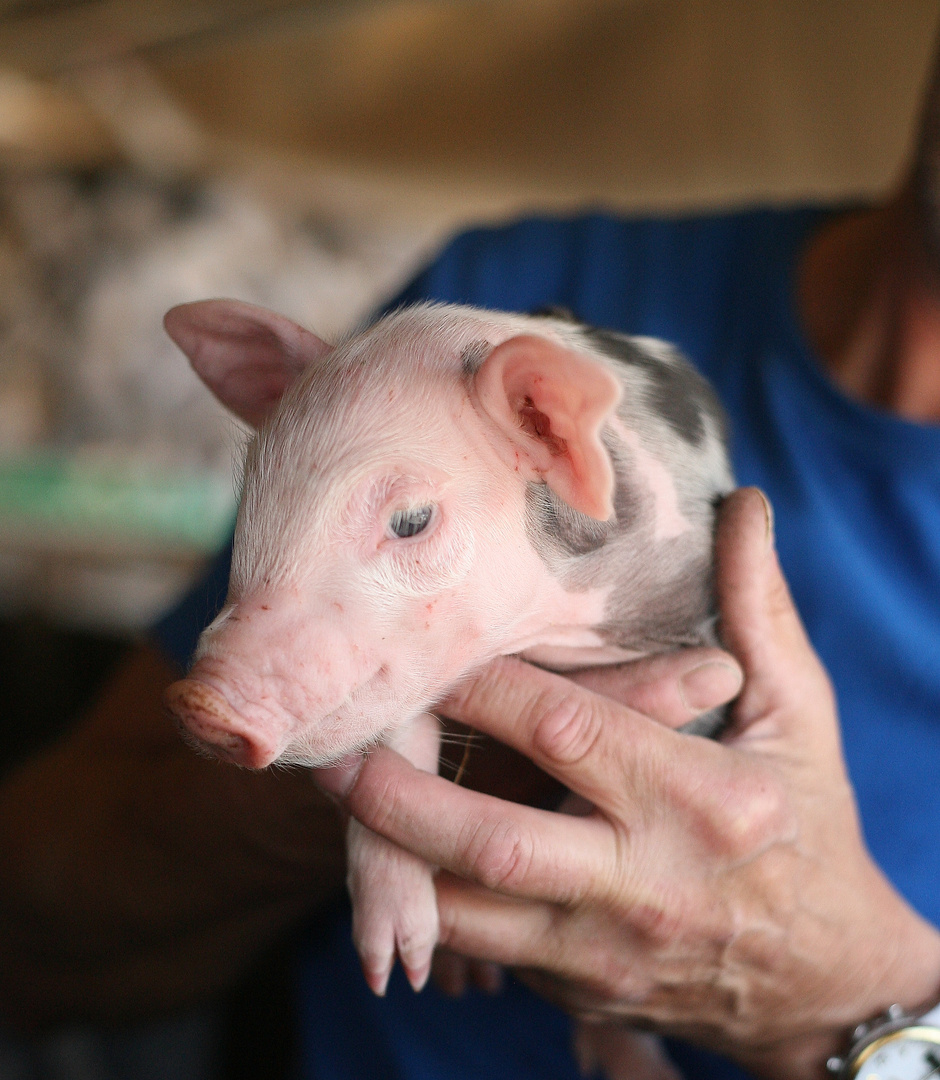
[[163, 678, 279, 769]]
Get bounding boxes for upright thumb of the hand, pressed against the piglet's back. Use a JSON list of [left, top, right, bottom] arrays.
[[715, 487, 832, 732]]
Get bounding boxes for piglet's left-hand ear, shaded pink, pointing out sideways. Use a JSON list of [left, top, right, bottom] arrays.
[[163, 300, 331, 428]]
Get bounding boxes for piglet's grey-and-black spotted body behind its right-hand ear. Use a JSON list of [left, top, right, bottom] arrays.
[[526, 313, 731, 652]]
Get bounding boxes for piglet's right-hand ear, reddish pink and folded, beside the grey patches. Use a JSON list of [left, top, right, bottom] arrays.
[[474, 335, 620, 521]]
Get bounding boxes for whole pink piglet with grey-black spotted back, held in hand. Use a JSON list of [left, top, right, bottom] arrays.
[[165, 300, 733, 1054]]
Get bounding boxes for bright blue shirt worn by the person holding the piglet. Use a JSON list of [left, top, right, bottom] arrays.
[[151, 208, 940, 1080]]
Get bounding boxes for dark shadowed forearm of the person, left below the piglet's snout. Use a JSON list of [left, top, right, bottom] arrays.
[[0, 648, 343, 1024]]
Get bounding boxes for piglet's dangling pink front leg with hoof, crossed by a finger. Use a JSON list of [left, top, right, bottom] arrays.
[[346, 713, 441, 995]]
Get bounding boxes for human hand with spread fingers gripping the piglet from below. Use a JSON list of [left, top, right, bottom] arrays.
[[328, 489, 940, 1078]]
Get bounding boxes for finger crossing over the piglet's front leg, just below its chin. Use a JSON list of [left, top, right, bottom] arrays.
[[344, 743, 613, 904]]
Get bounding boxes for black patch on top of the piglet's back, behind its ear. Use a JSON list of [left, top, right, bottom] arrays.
[[585, 327, 725, 446]]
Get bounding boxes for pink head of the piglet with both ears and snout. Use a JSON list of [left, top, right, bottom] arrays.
[[166, 300, 730, 768]]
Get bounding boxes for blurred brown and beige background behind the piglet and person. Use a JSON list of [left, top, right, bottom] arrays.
[[0, 0, 940, 1075]]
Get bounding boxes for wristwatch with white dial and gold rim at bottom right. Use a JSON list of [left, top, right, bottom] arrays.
[[825, 1004, 940, 1080]]
